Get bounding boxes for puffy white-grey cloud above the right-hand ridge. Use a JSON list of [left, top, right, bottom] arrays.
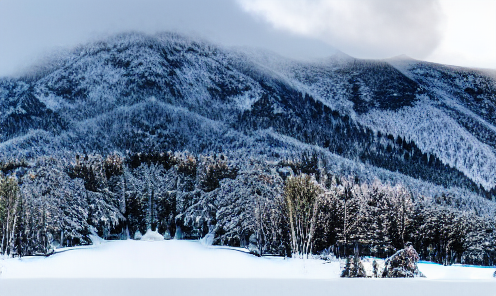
[[238, 0, 443, 59]]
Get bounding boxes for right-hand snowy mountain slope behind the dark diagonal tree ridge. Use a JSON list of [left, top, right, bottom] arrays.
[[252, 53, 496, 190]]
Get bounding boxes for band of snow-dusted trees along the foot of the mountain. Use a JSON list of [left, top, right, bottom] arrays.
[[0, 152, 496, 265]]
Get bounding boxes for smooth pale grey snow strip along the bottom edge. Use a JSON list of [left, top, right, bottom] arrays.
[[0, 278, 496, 296]]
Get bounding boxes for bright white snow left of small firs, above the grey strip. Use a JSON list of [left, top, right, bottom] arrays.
[[0, 239, 340, 279]]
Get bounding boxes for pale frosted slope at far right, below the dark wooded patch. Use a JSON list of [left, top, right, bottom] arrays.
[[359, 100, 496, 190]]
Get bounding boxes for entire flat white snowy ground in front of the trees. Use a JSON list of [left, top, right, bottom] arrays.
[[0, 236, 496, 296]]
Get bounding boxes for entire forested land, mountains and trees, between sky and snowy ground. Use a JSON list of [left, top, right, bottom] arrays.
[[0, 33, 496, 265]]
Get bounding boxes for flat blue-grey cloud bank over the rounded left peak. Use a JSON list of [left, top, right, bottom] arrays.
[[0, 0, 335, 77]]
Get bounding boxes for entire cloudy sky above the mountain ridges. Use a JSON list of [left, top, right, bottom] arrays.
[[0, 0, 496, 76]]
